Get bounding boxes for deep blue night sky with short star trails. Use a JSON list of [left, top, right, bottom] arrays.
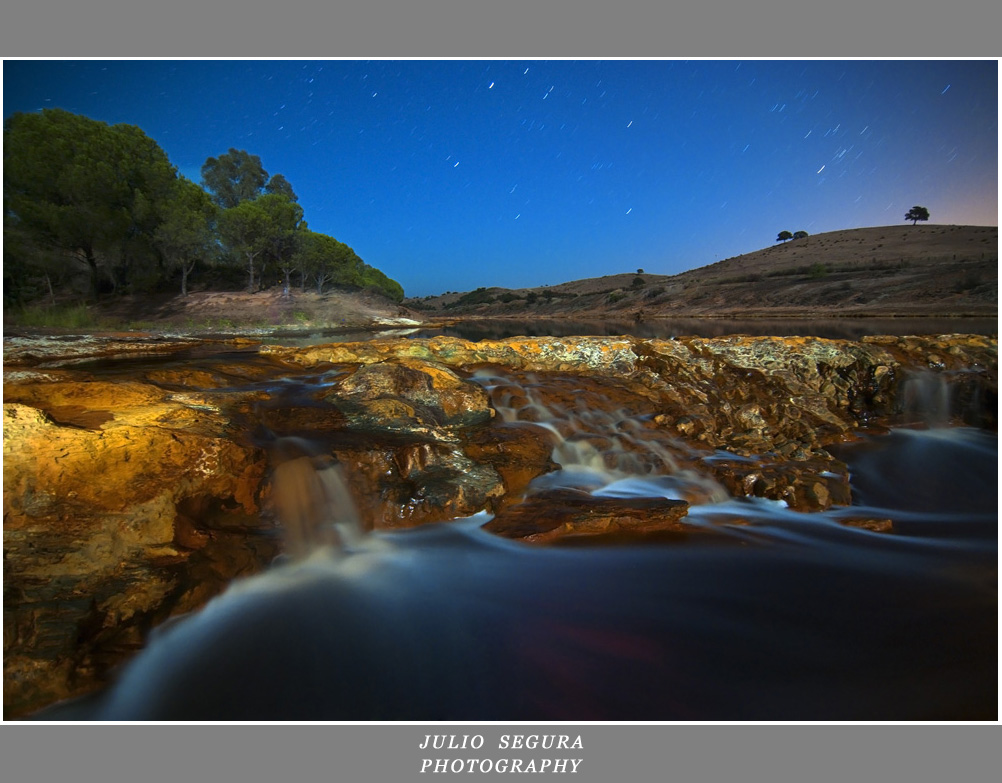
[[3, 60, 999, 296]]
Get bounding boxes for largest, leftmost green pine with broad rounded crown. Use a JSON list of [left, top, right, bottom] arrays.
[[4, 109, 176, 296]]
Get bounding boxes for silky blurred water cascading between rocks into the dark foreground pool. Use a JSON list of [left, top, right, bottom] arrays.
[[29, 338, 998, 721]]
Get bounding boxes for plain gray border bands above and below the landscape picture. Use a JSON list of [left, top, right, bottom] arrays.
[[0, 0, 1002, 783]]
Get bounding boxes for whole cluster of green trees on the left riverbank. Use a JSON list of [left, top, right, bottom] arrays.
[[3, 109, 404, 305]]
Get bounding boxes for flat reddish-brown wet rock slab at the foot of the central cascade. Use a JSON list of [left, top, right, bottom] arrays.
[[484, 489, 697, 543]]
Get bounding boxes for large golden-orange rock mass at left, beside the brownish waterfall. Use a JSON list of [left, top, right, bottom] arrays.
[[3, 383, 266, 715]]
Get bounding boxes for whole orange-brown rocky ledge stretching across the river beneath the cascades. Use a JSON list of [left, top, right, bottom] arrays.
[[3, 335, 997, 718]]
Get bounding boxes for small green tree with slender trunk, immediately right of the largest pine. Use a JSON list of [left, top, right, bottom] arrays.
[[153, 176, 218, 297]]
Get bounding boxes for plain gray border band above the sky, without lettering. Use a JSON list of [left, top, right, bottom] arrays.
[[0, 0, 1002, 59]]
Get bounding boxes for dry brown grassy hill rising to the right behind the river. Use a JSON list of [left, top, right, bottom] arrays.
[[404, 226, 998, 319]]
